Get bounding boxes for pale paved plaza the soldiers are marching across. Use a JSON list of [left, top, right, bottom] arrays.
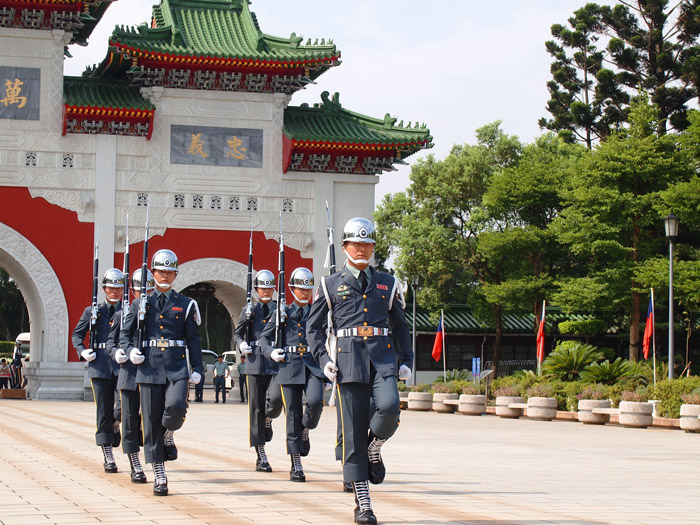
[[0, 390, 700, 525]]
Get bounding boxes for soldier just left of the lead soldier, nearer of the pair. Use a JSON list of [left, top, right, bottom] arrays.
[[260, 268, 324, 481]]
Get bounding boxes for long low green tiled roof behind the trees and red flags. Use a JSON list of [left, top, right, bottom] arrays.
[[405, 304, 604, 334]]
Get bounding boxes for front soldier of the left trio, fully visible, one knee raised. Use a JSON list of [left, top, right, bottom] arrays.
[[122, 250, 203, 496]]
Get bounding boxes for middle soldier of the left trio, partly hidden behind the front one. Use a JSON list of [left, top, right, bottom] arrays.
[[107, 268, 155, 483]]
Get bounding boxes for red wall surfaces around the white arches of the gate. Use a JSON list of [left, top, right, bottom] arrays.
[[0, 187, 312, 361]]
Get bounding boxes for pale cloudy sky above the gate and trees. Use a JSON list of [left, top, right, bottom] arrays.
[[65, 0, 590, 203]]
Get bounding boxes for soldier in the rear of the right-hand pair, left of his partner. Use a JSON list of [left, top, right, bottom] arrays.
[[233, 270, 282, 472]]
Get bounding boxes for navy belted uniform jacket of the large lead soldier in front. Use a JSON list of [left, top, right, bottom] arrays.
[[306, 268, 413, 384]]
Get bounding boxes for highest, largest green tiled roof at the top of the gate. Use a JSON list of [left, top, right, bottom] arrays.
[[110, 0, 337, 69]]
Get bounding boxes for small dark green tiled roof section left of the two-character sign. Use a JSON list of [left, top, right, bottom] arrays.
[[63, 77, 155, 111]]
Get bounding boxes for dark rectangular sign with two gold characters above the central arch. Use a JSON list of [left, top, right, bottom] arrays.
[[170, 125, 263, 168]]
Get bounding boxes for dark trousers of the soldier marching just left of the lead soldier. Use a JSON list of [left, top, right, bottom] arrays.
[[281, 368, 323, 454]]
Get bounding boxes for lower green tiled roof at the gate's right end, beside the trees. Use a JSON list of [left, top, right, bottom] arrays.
[[283, 91, 433, 149]]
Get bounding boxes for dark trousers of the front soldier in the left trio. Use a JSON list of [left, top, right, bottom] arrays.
[[139, 378, 189, 463]]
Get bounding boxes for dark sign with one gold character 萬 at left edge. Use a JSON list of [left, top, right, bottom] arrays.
[[0, 66, 41, 120]]
